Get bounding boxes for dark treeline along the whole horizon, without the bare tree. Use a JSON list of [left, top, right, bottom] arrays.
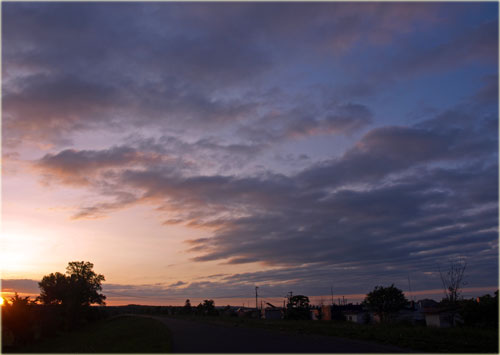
[[2, 261, 498, 352]]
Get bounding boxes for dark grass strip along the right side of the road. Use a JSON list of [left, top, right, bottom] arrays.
[[171, 317, 499, 354]]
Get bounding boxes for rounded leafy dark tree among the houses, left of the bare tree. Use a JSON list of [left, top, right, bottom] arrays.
[[363, 284, 408, 322]]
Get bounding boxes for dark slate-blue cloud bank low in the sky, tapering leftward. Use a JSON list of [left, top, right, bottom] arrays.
[[37, 99, 498, 292]]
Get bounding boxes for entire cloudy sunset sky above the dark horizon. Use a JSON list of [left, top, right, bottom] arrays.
[[1, 2, 499, 305]]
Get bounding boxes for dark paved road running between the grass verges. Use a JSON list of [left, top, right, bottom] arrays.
[[149, 316, 411, 354]]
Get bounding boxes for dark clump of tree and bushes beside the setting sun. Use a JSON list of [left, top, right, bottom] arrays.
[[2, 261, 106, 352]]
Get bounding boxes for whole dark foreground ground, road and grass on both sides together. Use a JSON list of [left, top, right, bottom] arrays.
[[6, 314, 498, 354]]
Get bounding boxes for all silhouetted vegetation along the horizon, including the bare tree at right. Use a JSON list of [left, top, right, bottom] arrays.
[[2, 261, 498, 352]]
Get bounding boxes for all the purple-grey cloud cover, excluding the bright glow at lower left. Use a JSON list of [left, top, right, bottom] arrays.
[[2, 3, 498, 294]]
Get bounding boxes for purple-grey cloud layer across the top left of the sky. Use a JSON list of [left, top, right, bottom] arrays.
[[3, 3, 492, 145]]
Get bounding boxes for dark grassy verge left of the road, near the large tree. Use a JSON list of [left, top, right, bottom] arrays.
[[9, 316, 172, 354]]
